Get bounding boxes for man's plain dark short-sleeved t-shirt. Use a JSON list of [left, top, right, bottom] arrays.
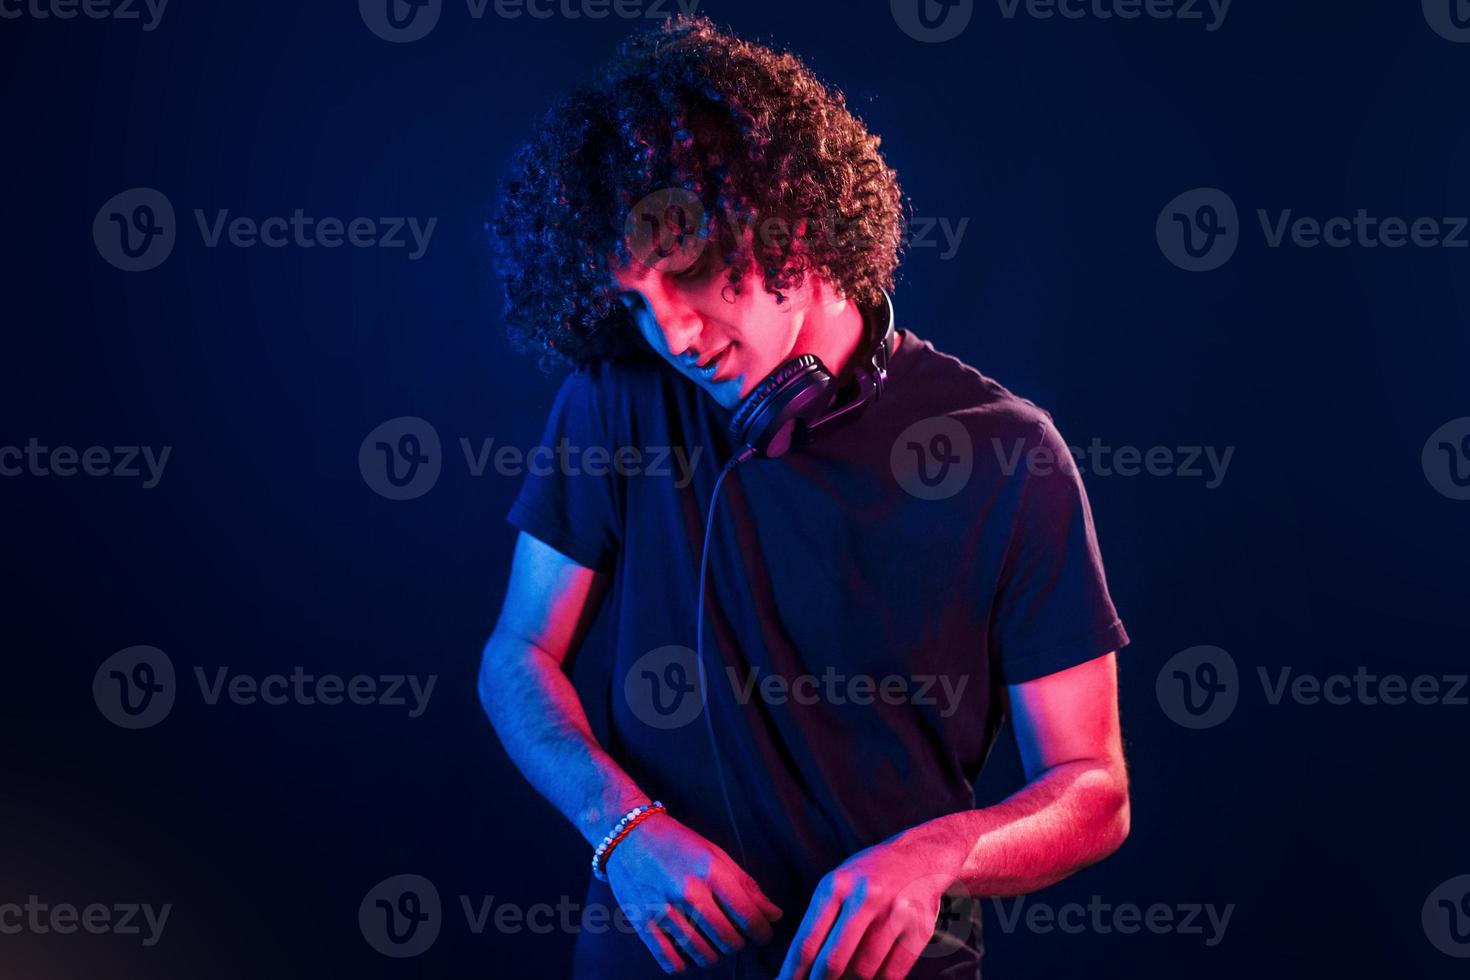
[[509, 323, 1127, 980]]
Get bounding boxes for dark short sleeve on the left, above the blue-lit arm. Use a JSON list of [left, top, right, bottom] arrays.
[[506, 372, 622, 572]]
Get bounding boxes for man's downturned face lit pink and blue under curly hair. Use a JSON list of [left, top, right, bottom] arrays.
[[614, 247, 809, 408]]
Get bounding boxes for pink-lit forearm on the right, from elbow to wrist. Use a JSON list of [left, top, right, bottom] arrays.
[[894, 761, 1129, 896]]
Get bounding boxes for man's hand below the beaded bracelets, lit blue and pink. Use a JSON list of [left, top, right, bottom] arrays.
[[607, 814, 782, 973]]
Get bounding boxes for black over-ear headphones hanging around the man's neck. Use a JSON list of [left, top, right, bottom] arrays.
[[729, 292, 895, 460]]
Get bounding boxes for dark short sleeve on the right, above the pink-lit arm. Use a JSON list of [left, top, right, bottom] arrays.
[[992, 422, 1129, 685]]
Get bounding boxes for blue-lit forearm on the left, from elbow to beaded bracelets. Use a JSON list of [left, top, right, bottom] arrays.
[[479, 632, 650, 845]]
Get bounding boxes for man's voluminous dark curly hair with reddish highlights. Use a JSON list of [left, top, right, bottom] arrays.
[[491, 16, 906, 367]]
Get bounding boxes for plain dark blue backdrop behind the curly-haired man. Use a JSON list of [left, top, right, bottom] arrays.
[[0, 0, 1470, 979]]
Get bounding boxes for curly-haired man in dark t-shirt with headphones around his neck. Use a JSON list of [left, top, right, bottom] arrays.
[[481, 19, 1129, 979]]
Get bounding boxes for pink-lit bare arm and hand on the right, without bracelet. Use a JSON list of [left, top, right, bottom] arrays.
[[781, 654, 1129, 980]]
